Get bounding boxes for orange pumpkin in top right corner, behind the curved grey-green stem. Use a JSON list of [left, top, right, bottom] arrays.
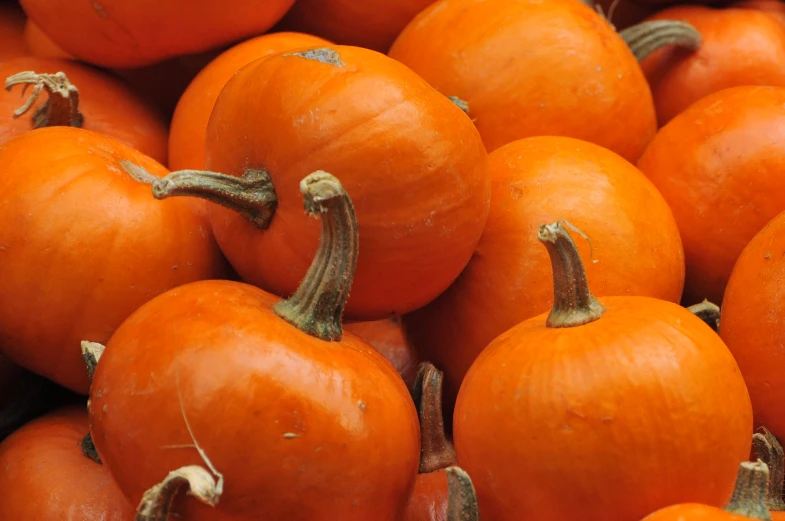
[[641, 6, 785, 126]]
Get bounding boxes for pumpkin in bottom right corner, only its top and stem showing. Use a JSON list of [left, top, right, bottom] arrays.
[[644, 461, 772, 521]]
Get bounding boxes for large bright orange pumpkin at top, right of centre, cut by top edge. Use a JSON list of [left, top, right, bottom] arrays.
[[390, 0, 657, 161]]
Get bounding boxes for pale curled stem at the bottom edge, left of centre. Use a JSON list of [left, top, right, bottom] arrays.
[[136, 465, 223, 521]]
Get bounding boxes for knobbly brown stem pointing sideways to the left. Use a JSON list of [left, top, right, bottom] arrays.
[[152, 168, 278, 230]]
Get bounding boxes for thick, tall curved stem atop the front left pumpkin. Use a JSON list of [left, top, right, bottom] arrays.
[[274, 170, 360, 340]]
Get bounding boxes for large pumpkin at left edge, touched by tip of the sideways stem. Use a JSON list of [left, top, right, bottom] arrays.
[[0, 127, 225, 394]]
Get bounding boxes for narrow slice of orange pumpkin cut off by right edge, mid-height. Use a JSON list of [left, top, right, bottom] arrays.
[[720, 209, 785, 437]]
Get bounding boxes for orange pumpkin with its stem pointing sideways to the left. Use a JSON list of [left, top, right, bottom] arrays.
[[153, 46, 490, 321]]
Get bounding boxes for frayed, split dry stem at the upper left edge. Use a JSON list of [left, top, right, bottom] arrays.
[[5, 71, 84, 128]]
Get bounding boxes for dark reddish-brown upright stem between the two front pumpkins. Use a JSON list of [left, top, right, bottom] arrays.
[[413, 362, 455, 474]]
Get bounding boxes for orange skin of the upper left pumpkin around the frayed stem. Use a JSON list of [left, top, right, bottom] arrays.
[[0, 57, 167, 163]]
